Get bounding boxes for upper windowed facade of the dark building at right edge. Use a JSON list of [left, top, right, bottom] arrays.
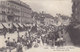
[[72, 0, 80, 23]]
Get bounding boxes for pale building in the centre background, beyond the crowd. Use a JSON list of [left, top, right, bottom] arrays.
[[44, 14, 62, 27]]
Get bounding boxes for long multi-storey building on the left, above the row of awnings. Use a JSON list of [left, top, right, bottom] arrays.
[[0, 0, 32, 23]]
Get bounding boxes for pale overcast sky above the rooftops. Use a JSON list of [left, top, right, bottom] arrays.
[[22, 0, 72, 16]]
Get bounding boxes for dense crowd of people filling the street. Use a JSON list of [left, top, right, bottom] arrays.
[[0, 24, 65, 52]]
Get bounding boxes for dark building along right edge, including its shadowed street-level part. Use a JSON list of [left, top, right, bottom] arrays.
[[67, 0, 80, 46]]
